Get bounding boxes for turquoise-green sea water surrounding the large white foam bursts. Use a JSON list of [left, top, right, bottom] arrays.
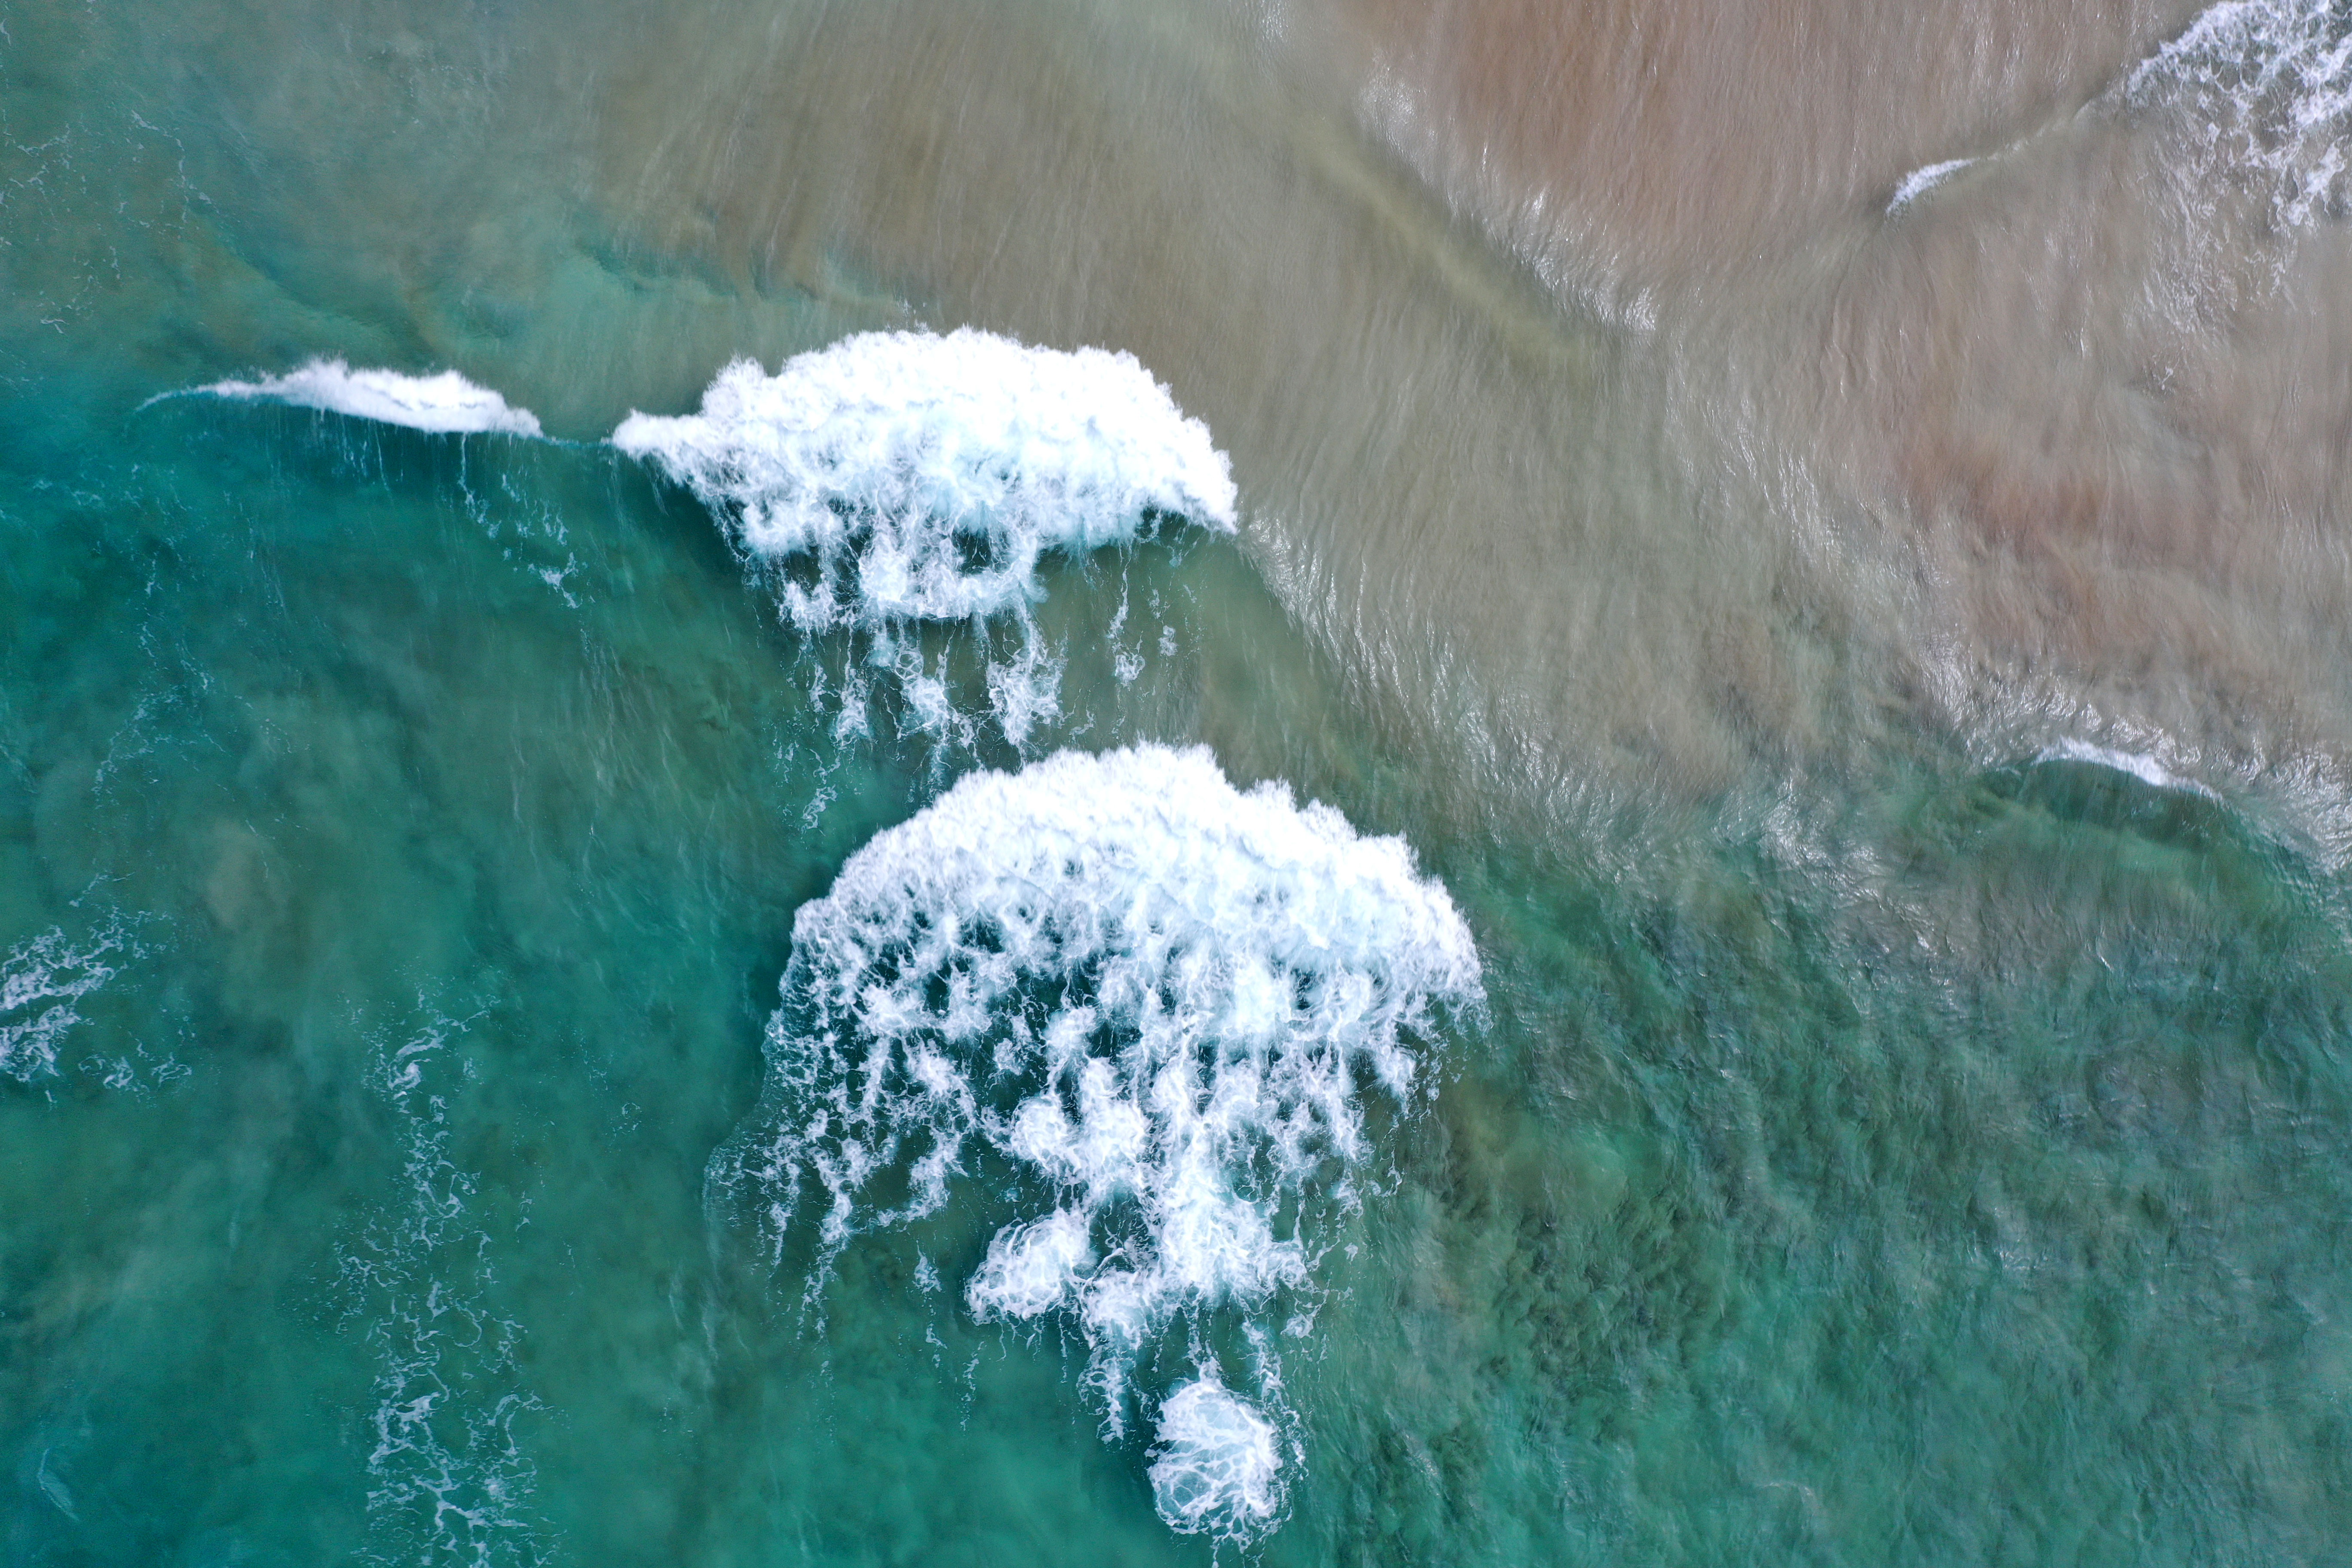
[[14, 7, 2352, 1568]]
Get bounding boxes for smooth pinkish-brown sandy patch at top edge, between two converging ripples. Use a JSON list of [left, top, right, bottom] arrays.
[[1298, 0, 2197, 289]]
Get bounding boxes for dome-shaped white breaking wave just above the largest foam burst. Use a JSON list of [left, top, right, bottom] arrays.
[[612, 327, 1235, 632]]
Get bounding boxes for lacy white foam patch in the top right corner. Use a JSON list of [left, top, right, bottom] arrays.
[[2122, 0, 2352, 228]]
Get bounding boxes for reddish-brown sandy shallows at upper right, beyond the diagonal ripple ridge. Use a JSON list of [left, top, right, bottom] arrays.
[[1298, 5, 2352, 832]]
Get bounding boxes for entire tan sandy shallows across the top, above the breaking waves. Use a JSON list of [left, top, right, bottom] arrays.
[[92, 0, 2352, 832]]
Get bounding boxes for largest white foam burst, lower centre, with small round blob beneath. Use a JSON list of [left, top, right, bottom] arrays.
[[713, 745, 1482, 1535]]
